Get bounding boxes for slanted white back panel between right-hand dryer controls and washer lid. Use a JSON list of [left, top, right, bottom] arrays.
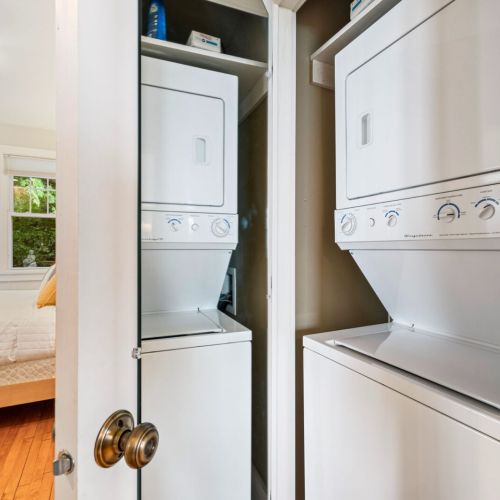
[[352, 250, 500, 347]]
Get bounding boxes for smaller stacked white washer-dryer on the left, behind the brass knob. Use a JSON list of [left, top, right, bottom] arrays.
[[141, 57, 251, 500]]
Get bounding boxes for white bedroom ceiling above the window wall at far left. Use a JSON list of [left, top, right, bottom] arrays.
[[0, 0, 56, 129]]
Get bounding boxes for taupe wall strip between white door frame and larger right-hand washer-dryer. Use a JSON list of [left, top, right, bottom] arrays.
[[296, 0, 387, 500]]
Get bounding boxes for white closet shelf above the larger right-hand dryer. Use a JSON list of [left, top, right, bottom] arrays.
[[311, 0, 401, 90]]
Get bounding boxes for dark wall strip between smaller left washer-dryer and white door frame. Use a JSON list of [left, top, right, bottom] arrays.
[[231, 99, 267, 483]]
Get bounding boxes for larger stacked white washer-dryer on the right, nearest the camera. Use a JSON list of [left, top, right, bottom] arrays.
[[304, 0, 500, 500]]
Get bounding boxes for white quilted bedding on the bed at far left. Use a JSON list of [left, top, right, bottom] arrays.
[[0, 290, 56, 366]]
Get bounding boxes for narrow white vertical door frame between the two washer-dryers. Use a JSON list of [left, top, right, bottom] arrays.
[[268, 0, 303, 500]]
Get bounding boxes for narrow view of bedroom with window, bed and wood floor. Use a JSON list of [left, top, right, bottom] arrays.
[[0, 0, 56, 498]]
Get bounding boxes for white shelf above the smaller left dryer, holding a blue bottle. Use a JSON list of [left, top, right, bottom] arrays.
[[141, 36, 267, 102]]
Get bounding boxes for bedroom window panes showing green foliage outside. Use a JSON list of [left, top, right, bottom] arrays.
[[9, 175, 56, 269]]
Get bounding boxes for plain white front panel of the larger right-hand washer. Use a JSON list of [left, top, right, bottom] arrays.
[[304, 349, 500, 500]]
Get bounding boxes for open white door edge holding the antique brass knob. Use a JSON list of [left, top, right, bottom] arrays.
[[55, 0, 143, 500]]
